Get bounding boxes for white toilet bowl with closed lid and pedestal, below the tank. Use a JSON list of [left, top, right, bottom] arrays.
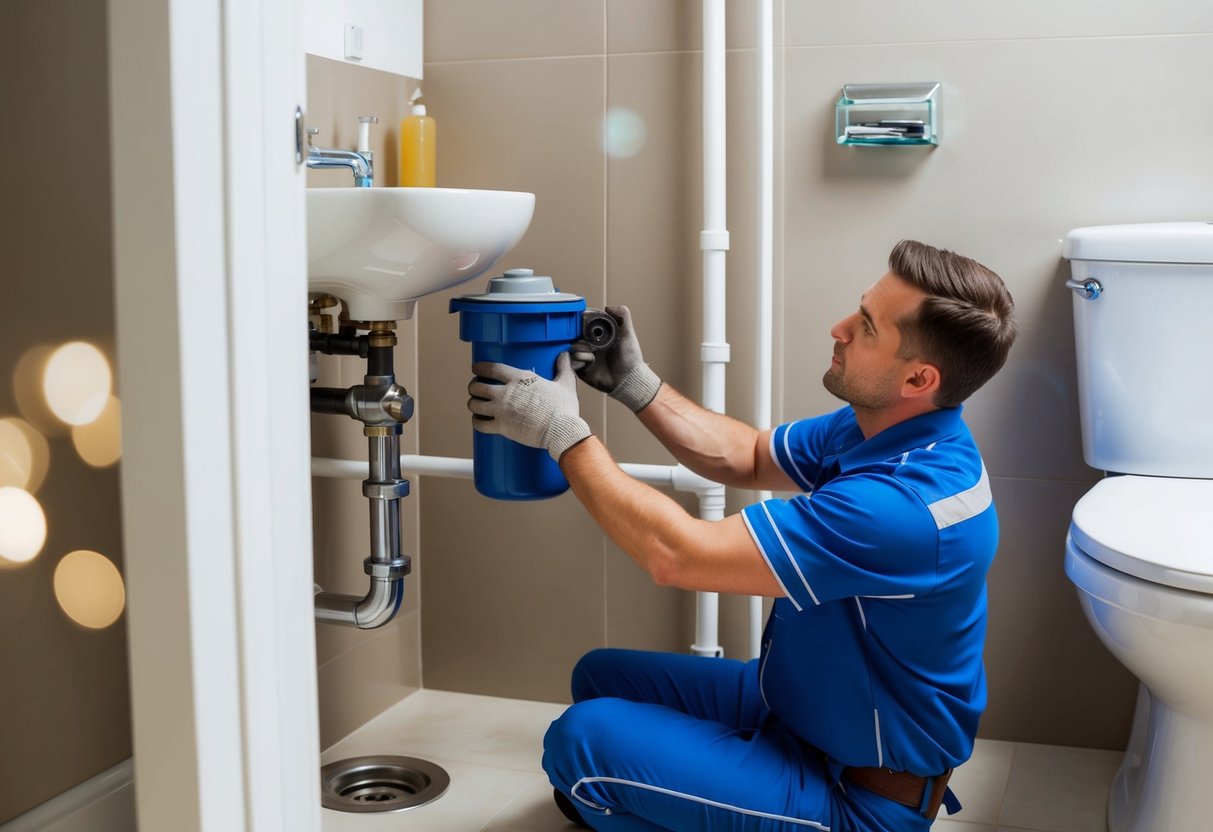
[[1065, 477, 1213, 832]]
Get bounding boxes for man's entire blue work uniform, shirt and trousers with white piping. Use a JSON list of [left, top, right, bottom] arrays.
[[543, 408, 997, 832]]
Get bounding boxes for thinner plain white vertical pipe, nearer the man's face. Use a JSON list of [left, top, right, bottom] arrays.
[[750, 0, 775, 657]]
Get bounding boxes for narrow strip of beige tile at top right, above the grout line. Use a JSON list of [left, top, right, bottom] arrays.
[[785, 0, 1213, 46]]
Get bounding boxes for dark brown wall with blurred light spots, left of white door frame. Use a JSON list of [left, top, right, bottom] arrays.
[[0, 0, 131, 824]]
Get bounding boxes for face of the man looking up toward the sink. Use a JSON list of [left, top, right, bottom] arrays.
[[821, 272, 927, 410]]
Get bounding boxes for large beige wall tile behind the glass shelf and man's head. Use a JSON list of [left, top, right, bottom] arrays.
[[784, 36, 1213, 479]]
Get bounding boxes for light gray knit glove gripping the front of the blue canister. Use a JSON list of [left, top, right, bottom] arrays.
[[467, 353, 590, 462]]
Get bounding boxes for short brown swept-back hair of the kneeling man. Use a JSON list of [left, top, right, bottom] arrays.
[[889, 240, 1016, 408]]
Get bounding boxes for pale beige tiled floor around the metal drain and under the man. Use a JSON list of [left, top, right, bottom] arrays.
[[321, 690, 1121, 832]]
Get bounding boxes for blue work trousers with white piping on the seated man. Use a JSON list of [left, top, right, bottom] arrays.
[[543, 649, 930, 832]]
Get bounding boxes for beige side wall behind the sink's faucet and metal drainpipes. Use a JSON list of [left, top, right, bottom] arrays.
[[307, 55, 422, 748]]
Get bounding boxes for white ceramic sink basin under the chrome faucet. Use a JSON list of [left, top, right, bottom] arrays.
[[307, 188, 535, 321]]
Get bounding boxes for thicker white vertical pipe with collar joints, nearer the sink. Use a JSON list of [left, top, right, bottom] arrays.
[[691, 0, 729, 656]]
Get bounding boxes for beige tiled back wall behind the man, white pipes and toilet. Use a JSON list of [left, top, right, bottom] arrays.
[[417, 0, 1213, 748]]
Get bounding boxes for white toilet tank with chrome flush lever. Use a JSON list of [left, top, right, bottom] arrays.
[[1063, 222, 1213, 479]]
